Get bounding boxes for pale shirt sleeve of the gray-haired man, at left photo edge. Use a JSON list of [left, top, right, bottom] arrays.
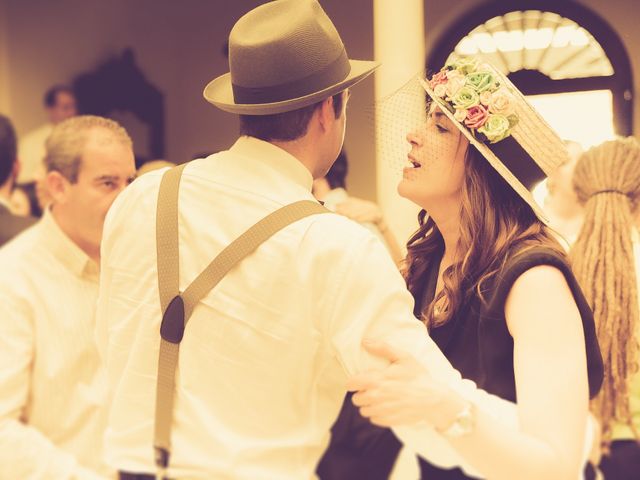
[[0, 285, 103, 480]]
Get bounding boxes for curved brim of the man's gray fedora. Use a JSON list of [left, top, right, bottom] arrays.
[[204, 60, 380, 115]]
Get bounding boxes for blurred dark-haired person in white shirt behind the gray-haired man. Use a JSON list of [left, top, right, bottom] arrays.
[[18, 85, 78, 216]]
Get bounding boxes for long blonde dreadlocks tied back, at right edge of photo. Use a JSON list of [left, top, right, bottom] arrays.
[[570, 137, 640, 451]]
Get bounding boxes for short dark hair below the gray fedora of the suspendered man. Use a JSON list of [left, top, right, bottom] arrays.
[[240, 92, 343, 142]]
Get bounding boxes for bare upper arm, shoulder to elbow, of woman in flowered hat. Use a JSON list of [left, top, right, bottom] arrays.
[[505, 265, 589, 478]]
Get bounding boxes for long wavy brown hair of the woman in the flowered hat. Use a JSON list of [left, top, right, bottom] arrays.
[[403, 145, 564, 327]]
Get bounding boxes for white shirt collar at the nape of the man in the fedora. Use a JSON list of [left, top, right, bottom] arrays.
[[229, 136, 313, 192]]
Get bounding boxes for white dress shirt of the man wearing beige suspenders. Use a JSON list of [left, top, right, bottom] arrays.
[[97, 137, 517, 480]]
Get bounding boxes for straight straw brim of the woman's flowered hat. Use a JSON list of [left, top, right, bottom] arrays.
[[420, 79, 549, 225]]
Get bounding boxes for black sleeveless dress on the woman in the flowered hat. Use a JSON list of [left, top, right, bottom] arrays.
[[414, 247, 603, 480]]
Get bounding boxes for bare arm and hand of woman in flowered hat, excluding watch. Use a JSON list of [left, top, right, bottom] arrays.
[[350, 266, 588, 480]]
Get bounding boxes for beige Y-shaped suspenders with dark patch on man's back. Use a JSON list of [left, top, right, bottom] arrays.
[[153, 164, 328, 478]]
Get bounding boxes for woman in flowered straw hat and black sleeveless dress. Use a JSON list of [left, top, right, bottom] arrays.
[[350, 58, 602, 480]]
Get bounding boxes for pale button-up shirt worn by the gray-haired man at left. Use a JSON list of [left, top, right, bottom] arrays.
[[0, 211, 108, 480]]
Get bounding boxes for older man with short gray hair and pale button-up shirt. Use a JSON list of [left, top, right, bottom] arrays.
[[0, 116, 135, 479]]
